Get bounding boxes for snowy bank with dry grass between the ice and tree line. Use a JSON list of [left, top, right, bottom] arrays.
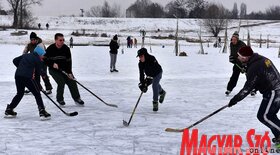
[[0, 16, 280, 46]]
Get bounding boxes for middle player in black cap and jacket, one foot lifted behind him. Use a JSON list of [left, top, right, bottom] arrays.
[[137, 48, 166, 111]]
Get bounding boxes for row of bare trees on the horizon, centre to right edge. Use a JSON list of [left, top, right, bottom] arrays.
[[86, 0, 280, 20]]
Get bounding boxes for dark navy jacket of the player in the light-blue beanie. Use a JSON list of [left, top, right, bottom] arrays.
[[13, 52, 46, 83]]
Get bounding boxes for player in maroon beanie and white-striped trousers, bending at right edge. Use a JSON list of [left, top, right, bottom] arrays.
[[228, 46, 280, 142]]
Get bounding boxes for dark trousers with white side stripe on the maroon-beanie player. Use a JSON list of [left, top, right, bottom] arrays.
[[257, 90, 280, 138]]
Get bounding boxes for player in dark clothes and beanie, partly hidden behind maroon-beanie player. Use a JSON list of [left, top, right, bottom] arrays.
[[225, 32, 246, 95]]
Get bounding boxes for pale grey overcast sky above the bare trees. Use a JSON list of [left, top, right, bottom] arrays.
[[0, 0, 280, 16]]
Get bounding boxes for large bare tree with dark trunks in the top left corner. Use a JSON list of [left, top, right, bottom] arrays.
[[7, 0, 41, 28]]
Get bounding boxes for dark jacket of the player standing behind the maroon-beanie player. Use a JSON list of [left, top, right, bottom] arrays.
[[229, 40, 246, 66]]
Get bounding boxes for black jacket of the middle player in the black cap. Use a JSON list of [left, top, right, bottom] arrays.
[[138, 53, 162, 83]]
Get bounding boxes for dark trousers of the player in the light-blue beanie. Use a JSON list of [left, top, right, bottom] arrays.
[[10, 76, 44, 110]]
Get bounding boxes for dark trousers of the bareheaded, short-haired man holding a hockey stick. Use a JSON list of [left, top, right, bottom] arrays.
[[49, 68, 80, 102]]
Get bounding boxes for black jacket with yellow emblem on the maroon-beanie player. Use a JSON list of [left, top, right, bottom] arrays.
[[233, 53, 280, 102]]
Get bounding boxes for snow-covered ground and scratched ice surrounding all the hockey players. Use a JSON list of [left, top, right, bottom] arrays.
[[0, 17, 280, 155]]
